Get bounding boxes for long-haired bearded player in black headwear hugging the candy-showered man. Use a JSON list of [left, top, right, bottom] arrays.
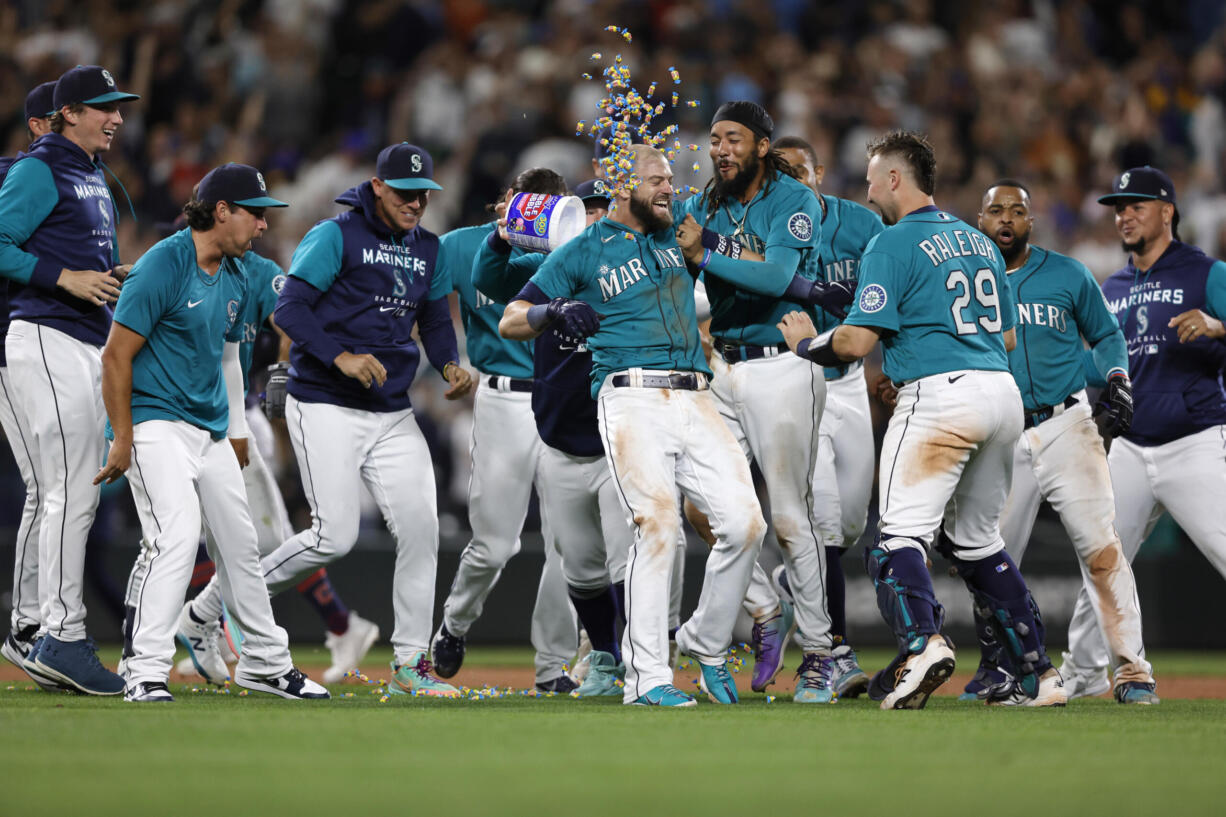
[[678, 102, 842, 703]]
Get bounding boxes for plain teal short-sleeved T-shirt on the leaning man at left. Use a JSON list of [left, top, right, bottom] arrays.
[[115, 229, 248, 439]]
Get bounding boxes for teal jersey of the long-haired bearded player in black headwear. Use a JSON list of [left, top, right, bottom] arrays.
[[678, 175, 821, 346]]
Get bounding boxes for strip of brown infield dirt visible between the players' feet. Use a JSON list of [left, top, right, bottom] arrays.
[[0, 661, 1226, 699]]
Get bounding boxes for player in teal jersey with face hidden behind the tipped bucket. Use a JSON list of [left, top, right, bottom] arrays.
[[432, 168, 579, 693]]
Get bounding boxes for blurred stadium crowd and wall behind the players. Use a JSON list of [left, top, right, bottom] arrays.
[[0, 0, 1226, 648]]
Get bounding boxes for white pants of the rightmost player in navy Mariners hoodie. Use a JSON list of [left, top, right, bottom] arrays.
[[1069, 426, 1226, 670]]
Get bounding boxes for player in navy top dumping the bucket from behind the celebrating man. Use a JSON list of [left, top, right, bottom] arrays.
[[472, 179, 632, 697]]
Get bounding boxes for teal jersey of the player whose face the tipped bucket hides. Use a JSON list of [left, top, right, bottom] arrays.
[[434, 223, 532, 379]]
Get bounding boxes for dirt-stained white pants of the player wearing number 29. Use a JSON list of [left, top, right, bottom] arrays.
[[877, 369, 1022, 554]]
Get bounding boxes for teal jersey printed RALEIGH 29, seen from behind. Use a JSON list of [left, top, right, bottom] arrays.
[[843, 206, 1016, 382]]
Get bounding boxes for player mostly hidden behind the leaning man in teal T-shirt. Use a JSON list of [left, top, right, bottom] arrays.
[[175, 250, 379, 685]]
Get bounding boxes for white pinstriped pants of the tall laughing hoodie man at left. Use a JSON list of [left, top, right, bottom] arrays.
[[5, 320, 107, 642]]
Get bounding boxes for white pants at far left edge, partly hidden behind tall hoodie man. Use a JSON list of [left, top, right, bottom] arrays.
[[0, 363, 43, 632]]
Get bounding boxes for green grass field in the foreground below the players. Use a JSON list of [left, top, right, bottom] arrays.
[[0, 649, 1226, 817]]
